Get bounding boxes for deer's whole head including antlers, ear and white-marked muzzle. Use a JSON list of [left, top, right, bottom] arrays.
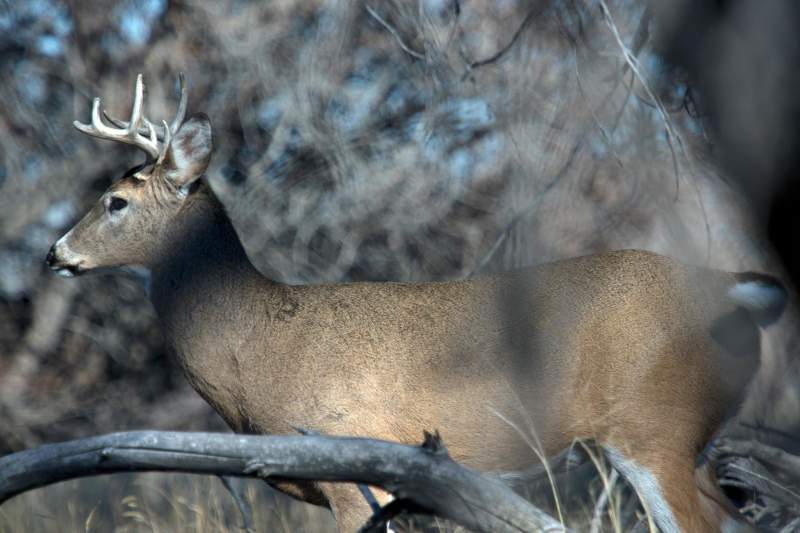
[[47, 74, 212, 276]]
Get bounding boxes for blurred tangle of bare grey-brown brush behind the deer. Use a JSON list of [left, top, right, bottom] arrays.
[[0, 0, 800, 531]]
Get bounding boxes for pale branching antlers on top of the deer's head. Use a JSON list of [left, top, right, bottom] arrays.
[[72, 73, 187, 165]]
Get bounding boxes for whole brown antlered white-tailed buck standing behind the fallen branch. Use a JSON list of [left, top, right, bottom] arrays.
[[47, 72, 786, 532]]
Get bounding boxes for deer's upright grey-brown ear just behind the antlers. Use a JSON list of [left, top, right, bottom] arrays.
[[165, 113, 213, 187]]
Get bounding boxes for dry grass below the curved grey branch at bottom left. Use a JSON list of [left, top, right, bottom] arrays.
[[0, 473, 336, 533]]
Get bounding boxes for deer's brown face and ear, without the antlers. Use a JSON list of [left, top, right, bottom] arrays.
[[47, 110, 211, 276]]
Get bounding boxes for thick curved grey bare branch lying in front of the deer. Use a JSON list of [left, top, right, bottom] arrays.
[[0, 431, 564, 532]]
